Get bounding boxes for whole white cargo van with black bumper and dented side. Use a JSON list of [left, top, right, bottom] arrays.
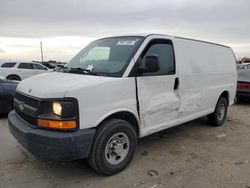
[[8, 34, 237, 175]]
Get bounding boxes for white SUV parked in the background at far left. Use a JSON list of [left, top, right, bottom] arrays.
[[0, 62, 50, 80]]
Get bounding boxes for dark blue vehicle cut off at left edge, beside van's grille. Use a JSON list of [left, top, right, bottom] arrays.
[[0, 76, 18, 114]]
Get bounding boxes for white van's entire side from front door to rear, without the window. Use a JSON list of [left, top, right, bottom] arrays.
[[138, 36, 237, 136]]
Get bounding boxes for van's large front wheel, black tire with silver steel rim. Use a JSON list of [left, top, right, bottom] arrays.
[[89, 119, 137, 176]]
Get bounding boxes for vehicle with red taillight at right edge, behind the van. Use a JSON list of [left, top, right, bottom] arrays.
[[236, 63, 250, 101]]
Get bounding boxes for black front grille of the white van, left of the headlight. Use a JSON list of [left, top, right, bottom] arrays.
[[14, 92, 39, 127]]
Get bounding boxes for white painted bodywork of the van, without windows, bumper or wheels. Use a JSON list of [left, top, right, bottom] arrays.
[[9, 34, 237, 174]]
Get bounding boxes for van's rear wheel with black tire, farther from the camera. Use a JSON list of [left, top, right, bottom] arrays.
[[207, 97, 228, 127]]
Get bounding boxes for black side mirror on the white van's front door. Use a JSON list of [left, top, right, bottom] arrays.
[[139, 55, 160, 73]]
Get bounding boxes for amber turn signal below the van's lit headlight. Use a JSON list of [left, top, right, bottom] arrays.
[[38, 119, 76, 129]]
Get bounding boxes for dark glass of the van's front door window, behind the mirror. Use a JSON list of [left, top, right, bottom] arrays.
[[142, 41, 175, 76]]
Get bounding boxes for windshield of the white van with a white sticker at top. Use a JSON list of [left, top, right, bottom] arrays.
[[65, 36, 144, 77]]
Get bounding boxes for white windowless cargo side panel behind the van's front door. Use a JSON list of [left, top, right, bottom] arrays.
[[174, 39, 237, 117]]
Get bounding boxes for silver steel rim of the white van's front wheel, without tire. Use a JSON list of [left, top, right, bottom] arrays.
[[105, 132, 129, 165]]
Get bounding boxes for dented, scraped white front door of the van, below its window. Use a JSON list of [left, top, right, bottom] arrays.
[[138, 75, 180, 128]]
